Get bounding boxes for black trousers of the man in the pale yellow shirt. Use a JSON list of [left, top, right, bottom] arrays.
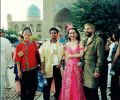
[[43, 66, 62, 100]]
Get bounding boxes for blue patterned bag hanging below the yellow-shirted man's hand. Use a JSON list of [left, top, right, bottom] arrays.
[[37, 71, 47, 92]]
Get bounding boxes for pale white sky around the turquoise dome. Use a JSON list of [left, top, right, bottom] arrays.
[[1, 0, 43, 29]]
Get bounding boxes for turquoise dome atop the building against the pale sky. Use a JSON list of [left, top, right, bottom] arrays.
[[27, 4, 40, 17]]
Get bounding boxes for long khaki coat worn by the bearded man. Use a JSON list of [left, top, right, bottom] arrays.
[[83, 35, 104, 88]]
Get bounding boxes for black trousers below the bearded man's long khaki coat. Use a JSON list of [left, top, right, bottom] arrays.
[[84, 87, 99, 100]]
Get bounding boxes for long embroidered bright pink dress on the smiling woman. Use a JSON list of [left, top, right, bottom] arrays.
[[59, 46, 86, 100]]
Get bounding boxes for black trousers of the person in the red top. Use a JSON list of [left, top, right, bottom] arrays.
[[20, 69, 37, 100]]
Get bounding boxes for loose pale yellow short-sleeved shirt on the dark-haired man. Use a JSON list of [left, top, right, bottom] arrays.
[[39, 41, 64, 78]]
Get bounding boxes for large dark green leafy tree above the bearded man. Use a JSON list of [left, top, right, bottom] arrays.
[[71, 0, 120, 32]]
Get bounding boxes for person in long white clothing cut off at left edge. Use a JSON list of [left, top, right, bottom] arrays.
[[0, 29, 13, 99]]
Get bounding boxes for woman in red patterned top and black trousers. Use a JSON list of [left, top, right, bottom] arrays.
[[15, 27, 39, 100]]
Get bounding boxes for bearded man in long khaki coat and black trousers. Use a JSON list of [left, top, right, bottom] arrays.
[[83, 23, 104, 100]]
